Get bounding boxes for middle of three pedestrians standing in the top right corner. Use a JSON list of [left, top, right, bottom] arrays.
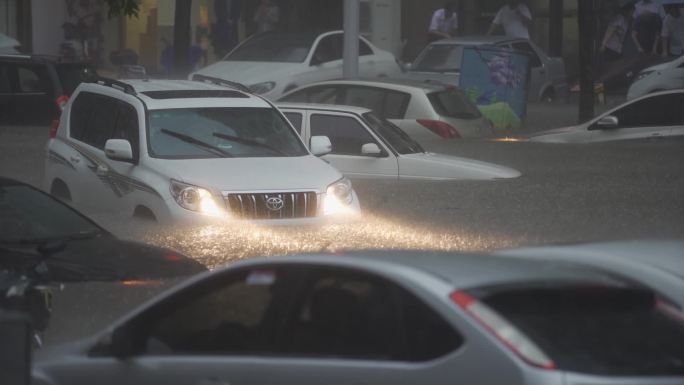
[[632, 0, 665, 54]]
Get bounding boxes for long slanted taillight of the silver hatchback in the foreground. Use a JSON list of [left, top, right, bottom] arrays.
[[449, 291, 556, 369]]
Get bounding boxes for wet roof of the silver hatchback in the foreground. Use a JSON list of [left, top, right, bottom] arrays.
[[222, 251, 626, 289]]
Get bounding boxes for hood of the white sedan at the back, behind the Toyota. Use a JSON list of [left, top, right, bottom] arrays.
[[191, 61, 303, 86]]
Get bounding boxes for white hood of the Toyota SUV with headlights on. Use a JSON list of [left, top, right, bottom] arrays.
[[153, 155, 342, 192]]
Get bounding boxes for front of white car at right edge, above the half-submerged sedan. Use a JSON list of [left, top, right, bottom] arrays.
[[627, 56, 684, 100]]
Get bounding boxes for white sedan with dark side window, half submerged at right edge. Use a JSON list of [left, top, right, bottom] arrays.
[[529, 90, 684, 143]]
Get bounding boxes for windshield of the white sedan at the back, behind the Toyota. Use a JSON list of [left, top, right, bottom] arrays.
[[223, 33, 314, 63]]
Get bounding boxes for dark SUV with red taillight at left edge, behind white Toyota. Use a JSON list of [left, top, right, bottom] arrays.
[[0, 54, 95, 125]]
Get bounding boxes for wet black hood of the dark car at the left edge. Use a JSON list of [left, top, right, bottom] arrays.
[[0, 236, 207, 282]]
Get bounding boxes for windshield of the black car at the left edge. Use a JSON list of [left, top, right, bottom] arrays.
[[0, 184, 103, 243]]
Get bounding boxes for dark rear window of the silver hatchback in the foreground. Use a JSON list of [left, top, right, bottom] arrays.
[[483, 286, 684, 375]]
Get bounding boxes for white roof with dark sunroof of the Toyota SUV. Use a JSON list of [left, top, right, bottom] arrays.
[[109, 79, 270, 110]]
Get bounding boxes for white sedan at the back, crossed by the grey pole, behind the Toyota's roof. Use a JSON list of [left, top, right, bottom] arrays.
[[191, 31, 401, 100]]
